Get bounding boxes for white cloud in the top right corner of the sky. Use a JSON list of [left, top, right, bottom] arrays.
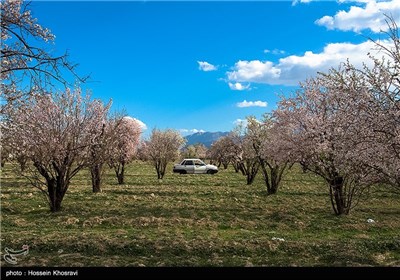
[[315, 0, 400, 33]]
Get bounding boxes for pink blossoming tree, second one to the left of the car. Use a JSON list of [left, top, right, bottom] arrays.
[[107, 116, 142, 185]]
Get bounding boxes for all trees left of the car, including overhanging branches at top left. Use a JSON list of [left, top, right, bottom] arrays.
[[0, 0, 184, 212]]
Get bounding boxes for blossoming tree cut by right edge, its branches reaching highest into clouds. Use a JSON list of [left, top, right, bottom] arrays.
[[354, 16, 400, 191]]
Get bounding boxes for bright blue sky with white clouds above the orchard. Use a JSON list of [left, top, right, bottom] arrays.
[[31, 0, 400, 135]]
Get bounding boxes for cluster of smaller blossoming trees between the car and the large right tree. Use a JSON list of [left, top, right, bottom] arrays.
[[207, 114, 291, 194]]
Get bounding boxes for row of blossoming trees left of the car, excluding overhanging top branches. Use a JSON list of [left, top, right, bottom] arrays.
[[2, 89, 188, 212]]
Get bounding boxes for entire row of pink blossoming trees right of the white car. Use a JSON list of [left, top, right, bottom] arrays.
[[208, 17, 400, 215]]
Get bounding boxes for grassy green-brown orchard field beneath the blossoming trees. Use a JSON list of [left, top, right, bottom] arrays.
[[1, 162, 400, 267]]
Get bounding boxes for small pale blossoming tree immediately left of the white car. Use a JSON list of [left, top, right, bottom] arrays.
[[146, 129, 185, 179]]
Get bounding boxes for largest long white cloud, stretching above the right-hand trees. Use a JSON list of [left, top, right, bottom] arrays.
[[226, 38, 389, 85]]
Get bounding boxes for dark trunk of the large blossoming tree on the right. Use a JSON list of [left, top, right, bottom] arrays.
[[328, 176, 350, 216]]
